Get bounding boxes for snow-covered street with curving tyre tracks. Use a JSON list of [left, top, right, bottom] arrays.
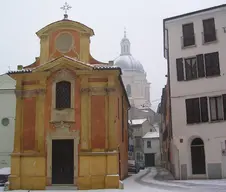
[[1, 168, 226, 192]]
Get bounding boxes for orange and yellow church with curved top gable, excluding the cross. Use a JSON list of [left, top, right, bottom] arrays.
[[9, 14, 130, 190]]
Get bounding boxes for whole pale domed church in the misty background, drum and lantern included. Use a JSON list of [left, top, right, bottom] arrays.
[[114, 32, 150, 108]]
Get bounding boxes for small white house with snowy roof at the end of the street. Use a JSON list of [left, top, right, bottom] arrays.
[[143, 131, 160, 167]]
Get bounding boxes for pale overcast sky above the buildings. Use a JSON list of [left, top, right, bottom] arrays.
[[0, 0, 225, 108]]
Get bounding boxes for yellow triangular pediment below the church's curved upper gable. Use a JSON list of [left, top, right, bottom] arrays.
[[33, 56, 93, 72]]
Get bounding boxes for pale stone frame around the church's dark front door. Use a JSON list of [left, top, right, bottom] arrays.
[[46, 124, 80, 186]]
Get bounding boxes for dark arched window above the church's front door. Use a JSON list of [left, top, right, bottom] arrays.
[[56, 81, 71, 109]]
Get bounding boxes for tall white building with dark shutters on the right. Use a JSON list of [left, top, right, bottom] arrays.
[[163, 5, 226, 179]]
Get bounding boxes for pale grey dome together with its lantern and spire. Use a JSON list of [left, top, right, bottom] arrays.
[[114, 32, 144, 73]]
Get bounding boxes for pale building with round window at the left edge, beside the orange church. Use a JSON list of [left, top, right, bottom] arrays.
[[0, 75, 16, 168]]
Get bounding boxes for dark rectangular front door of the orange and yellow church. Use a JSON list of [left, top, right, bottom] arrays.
[[52, 139, 74, 184]]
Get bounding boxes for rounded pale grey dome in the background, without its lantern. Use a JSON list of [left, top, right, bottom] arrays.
[[114, 55, 144, 73]]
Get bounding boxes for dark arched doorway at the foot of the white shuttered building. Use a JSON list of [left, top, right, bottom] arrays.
[[191, 138, 206, 175]]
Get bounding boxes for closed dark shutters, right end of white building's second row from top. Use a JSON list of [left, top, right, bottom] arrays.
[[205, 52, 220, 77]]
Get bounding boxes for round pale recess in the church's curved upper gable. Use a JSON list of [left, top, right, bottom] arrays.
[[56, 33, 73, 53]]
